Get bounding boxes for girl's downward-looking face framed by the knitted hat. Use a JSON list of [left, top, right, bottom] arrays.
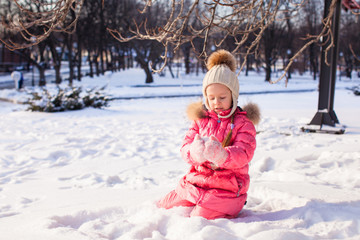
[[206, 83, 232, 114]]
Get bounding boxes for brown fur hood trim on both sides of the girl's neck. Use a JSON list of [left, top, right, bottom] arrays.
[[186, 101, 261, 125]]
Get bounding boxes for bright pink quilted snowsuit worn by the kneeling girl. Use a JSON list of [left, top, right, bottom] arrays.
[[158, 108, 256, 219]]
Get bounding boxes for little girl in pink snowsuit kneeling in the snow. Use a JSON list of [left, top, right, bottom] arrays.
[[158, 50, 260, 219]]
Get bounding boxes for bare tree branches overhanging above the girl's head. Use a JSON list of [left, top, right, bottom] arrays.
[[109, 0, 356, 83]]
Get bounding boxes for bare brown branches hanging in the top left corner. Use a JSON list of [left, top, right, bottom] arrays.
[[0, 0, 83, 50]]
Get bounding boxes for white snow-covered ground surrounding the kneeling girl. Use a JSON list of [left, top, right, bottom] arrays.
[[0, 69, 360, 240]]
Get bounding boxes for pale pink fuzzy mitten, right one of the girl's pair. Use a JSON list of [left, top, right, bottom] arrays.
[[204, 136, 229, 166]]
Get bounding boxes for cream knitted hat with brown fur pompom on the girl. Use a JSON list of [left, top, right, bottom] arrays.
[[203, 49, 239, 118]]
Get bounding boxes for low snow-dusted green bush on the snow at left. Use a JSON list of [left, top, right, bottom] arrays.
[[27, 87, 110, 112]]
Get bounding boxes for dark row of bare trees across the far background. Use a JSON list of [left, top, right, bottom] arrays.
[[0, 0, 360, 85]]
